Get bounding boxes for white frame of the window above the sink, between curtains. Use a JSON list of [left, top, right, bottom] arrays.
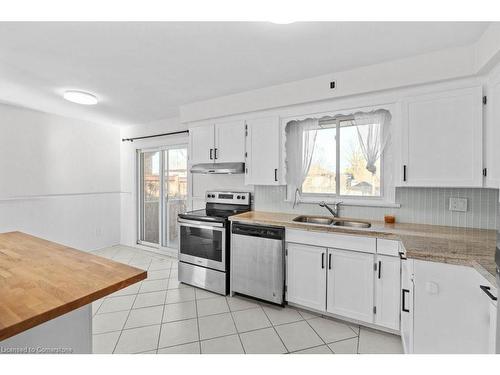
[[298, 115, 386, 205]]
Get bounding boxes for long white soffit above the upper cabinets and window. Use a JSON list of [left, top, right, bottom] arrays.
[[180, 23, 500, 122]]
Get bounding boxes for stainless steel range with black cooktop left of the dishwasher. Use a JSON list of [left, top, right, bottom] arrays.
[[177, 191, 251, 295]]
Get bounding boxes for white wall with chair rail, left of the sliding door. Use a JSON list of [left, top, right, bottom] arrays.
[[0, 104, 120, 250]]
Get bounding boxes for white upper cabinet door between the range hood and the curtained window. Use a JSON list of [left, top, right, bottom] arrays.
[[245, 117, 280, 185]]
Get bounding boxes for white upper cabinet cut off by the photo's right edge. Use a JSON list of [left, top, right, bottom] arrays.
[[484, 74, 500, 188]]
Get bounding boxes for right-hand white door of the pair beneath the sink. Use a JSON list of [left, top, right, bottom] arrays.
[[326, 249, 374, 323]]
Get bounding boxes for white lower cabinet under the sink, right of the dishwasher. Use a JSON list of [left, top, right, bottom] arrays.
[[286, 229, 401, 331]]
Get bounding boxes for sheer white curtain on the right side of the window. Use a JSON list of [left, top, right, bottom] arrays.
[[354, 110, 391, 174]]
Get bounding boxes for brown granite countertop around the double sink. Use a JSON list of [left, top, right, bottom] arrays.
[[229, 211, 497, 285]]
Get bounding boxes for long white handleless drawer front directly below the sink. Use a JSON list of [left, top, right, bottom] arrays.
[[285, 229, 376, 255]]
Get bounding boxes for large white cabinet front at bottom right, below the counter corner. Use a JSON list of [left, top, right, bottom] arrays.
[[413, 260, 490, 354]]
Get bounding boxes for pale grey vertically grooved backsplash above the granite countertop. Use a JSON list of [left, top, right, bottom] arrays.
[[254, 186, 500, 229]]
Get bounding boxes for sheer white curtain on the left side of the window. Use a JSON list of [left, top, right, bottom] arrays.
[[285, 118, 319, 207]]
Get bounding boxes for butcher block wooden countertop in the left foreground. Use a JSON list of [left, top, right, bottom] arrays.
[[0, 232, 147, 341]]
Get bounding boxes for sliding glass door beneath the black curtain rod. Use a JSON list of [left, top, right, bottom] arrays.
[[138, 145, 187, 248]]
